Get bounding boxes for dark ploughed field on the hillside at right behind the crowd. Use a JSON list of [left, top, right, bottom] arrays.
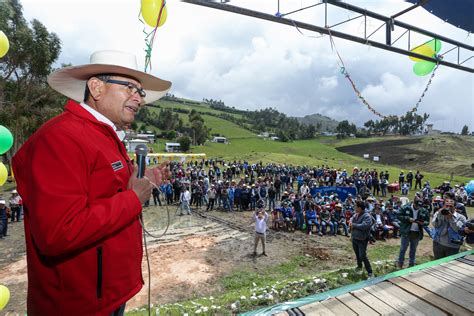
[[337, 136, 474, 177]]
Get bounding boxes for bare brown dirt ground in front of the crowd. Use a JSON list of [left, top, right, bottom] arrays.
[[0, 202, 456, 315]]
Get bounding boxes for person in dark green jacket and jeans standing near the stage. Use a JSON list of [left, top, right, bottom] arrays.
[[397, 197, 430, 269]]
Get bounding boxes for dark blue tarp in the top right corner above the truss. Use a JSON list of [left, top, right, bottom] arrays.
[[405, 0, 474, 33]]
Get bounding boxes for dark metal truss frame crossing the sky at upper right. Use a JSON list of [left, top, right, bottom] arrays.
[[182, 0, 474, 73]]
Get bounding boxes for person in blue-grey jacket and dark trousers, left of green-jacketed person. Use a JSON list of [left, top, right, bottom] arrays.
[[349, 200, 373, 278]]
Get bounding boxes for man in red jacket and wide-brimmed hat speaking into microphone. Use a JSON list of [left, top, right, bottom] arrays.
[[13, 51, 171, 315]]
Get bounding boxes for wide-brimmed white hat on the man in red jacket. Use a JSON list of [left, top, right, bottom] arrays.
[[48, 50, 171, 103]]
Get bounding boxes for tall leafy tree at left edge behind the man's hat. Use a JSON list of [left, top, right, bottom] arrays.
[[0, 0, 65, 152]]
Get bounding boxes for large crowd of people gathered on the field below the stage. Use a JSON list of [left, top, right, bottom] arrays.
[[146, 160, 474, 277]]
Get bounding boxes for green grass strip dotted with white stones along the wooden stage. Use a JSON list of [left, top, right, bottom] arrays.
[[127, 256, 395, 315]]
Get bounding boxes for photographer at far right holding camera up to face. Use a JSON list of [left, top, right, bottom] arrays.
[[432, 197, 466, 259]]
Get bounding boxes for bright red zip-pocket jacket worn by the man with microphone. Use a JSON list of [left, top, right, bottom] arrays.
[[13, 101, 143, 316]]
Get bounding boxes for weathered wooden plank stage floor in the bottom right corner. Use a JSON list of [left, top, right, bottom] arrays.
[[273, 254, 474, 316]]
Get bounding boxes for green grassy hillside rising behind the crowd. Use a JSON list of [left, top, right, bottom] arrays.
[[140, 96, 474, 185]]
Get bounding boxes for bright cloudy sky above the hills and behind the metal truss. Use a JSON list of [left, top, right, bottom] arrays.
[[20, 0, 474, 133]]
